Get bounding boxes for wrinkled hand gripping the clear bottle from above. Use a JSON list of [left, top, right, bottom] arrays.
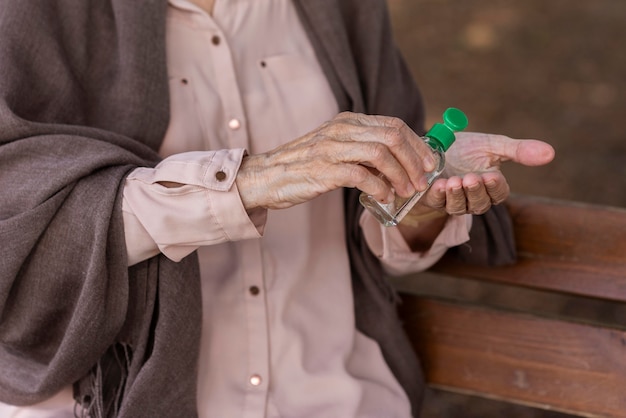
[[237, 112, 435, 209]]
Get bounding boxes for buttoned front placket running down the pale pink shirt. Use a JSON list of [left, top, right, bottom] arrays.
[[194, 8, 270, 418]]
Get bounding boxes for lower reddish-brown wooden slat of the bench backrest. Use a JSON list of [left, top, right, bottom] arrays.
[[400, 294, 626, 417]]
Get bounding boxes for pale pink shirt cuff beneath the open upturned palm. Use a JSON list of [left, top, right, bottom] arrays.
[[359, 211, 472, 276]]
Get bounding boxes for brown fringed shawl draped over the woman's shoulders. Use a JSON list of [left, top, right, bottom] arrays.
[[0, 0, 513, 417]]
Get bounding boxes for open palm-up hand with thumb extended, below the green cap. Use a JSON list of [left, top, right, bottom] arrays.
[[414, 132, 554, 215]]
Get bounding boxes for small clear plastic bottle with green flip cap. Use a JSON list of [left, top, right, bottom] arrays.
[[359, 107, 468, 226]]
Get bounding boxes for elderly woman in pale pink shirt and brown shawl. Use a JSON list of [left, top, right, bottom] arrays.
[[0, 0, 553, 418]]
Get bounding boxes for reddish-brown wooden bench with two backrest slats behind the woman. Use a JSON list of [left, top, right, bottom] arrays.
[[393, 195, 626, 418]]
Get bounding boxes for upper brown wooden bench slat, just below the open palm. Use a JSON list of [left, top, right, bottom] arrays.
[[432, 195, 626, 301]]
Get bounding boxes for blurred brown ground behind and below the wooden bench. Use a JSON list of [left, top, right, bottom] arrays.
[[388, 0, 626, 418]]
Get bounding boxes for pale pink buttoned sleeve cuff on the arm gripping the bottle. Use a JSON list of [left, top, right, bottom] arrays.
[[122, 149, 267, 264]]
